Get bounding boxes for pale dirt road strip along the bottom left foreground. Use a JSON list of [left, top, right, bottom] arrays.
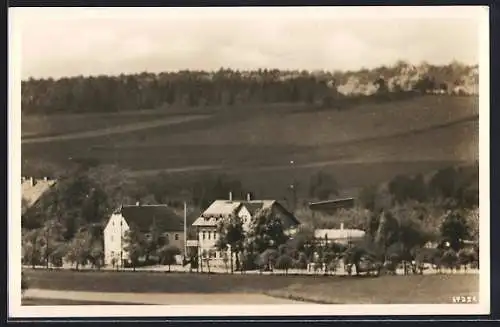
[[25, 289, 306, 305]]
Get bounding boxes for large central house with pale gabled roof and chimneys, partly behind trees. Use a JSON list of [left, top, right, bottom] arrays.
[[190, 195, 300, 266]]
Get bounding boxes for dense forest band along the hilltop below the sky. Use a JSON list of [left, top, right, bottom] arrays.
[[21, 61, 479, 114]]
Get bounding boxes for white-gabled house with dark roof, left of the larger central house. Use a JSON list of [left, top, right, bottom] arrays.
[[104, 203, 184, 265]]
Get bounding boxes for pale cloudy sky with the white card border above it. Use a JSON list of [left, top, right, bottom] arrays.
[[9, 7, 487, 79]]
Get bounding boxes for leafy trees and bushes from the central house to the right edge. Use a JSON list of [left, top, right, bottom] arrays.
[[213, 202, 478, 273]]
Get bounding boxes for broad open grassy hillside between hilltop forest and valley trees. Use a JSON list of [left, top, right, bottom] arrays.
[[22, 96, 479, 197]]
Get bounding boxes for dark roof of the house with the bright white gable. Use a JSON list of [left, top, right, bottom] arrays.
[[120, 205, 184, 232]]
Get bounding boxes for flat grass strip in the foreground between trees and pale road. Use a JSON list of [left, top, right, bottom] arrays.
[[25, 270, 479, 304]]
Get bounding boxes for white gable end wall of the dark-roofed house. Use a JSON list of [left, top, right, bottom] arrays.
[[104, 214, 130, 266]]
